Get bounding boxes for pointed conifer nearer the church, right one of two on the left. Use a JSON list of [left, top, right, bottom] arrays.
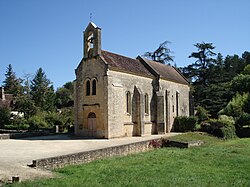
[[30, 68, 55, 111]]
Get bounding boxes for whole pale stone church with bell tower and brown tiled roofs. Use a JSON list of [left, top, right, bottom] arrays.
[[74, 22, 190, 138]]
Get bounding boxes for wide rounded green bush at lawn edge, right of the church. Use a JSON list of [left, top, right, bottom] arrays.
[[201, 116, 237, 139]]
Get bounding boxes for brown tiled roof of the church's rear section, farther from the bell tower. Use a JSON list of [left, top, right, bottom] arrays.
[[142, 58, 189, 85]]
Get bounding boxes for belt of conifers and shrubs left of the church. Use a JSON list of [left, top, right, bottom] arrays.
[[0, 65, 74, 130]]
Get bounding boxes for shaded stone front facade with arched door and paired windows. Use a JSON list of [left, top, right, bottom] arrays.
[[74, 57, 108, 138]]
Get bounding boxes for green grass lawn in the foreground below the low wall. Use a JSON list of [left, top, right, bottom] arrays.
[[9, 133, 250, 187]]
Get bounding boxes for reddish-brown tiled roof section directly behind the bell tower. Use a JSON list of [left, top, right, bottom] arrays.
[[101, 50, 153, 77]]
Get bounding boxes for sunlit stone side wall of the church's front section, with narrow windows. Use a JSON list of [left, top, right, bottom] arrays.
[[108, 70, 155, 138]]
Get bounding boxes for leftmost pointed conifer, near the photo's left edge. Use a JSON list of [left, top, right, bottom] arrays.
[[3, 64, 22, 96]]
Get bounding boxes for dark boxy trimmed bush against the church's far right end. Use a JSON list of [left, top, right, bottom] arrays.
[[173, 116, 197, 132]]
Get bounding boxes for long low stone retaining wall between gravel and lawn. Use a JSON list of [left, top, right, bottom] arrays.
[[30, 138, 160, 169]]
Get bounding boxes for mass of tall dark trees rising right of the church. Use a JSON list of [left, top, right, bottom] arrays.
[[182, 42, 250, 117]]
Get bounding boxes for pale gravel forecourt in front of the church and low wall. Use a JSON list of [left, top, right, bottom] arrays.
[[0, 133, 180, 181]]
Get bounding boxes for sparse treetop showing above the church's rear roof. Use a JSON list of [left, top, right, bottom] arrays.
[[143, 41, 174, 64]]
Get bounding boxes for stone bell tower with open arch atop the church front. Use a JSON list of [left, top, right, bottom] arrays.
[[83, 22, 101, 58]]
